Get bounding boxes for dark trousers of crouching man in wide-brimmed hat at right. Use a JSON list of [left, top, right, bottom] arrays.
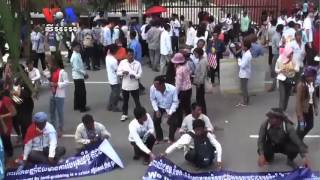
[[263, 141, 299, 162]]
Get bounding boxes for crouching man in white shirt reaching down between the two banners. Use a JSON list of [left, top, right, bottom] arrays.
[[128, 106, 156, 165]]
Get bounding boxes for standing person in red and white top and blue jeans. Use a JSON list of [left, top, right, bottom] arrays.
[[48, 58, 69, 137]]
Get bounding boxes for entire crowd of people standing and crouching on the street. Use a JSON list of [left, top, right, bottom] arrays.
[[0, 0, 320, 174]]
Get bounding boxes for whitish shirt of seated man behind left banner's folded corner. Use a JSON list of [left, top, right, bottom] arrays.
[[74, 122, 111, 145]]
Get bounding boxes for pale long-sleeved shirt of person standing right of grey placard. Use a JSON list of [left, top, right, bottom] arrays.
[[238, 50, 252, 79]]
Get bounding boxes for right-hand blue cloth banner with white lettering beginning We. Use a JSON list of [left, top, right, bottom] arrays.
[[142, 158, 320, 180]]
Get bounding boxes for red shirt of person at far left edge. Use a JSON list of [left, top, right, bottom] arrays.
[[0, 96, 13, 135]]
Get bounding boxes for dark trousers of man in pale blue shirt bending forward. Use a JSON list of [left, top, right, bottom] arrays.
[[153, 108, 178, 141]]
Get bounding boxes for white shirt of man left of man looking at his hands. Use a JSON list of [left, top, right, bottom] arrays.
[[106, 54, 119, 85]]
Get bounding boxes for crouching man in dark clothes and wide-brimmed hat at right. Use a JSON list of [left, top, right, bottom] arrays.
[[258, 108, 308, 169]]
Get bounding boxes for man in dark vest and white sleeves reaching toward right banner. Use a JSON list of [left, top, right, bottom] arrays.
[[163, 119, 222, 170]]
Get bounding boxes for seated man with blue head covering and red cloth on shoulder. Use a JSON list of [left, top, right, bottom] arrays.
[[23, 112, 66, 165]]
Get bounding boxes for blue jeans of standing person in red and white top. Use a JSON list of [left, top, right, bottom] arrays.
[[50, 96, 64, 131]]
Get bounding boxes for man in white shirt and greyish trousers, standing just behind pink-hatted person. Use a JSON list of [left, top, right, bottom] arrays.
[[160, 24, 172, 75]]
